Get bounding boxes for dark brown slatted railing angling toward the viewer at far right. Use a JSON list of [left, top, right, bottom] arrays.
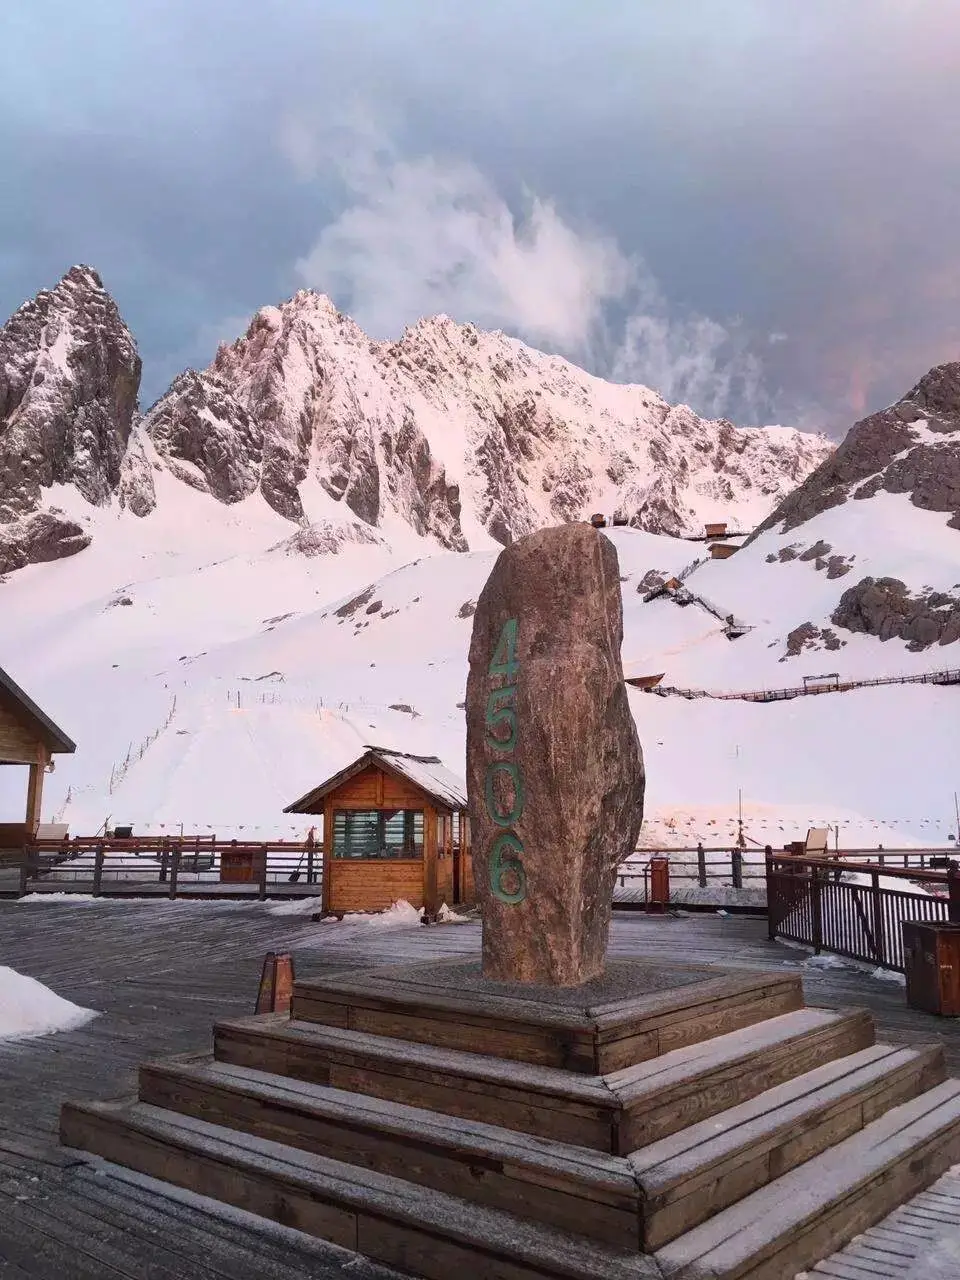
[[765, 847, 960, 973]]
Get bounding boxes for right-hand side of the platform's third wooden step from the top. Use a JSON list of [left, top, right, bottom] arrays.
[[628, 1044, 946, 1252]]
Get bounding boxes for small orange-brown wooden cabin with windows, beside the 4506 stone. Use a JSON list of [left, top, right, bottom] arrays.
[[284, 746, 474, 916]]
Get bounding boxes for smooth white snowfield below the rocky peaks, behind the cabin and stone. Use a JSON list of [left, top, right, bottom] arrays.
[[0, 504, 960, 844]]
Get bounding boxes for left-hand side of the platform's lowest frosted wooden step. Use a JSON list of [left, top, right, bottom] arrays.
[[60, 1102, 660, 1280]]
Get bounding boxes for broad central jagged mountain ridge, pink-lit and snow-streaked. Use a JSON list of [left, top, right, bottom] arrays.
[[145, 291, 832, 550]]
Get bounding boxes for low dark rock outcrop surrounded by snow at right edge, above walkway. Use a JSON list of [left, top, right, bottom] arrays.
[[831, 577, 960, 652]]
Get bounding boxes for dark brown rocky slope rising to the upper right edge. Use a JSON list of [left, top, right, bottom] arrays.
[[745, 362, 960, 545]]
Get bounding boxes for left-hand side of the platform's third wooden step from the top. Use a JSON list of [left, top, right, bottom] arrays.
[[140, 1055, 640, 1249]]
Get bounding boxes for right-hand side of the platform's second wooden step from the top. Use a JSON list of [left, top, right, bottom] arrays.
[[603, 1009, 874, 1153]]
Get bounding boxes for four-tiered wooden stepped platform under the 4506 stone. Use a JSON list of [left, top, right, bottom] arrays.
[[61, 959, 960, 1280]]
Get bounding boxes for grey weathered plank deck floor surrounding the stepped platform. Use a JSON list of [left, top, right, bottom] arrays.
[[0, 901, 960, 1280]]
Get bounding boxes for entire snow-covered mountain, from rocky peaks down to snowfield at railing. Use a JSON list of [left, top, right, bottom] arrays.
[[0, 264, 960, 845]]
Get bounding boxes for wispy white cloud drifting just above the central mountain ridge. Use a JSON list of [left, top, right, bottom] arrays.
[[280, 113, 764, 420]]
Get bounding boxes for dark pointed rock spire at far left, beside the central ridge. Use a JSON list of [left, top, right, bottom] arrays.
[[0, 266, 141, 563]]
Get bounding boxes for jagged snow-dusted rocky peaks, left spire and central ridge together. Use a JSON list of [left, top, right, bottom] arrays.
[[0, 268, 833, 572]]
